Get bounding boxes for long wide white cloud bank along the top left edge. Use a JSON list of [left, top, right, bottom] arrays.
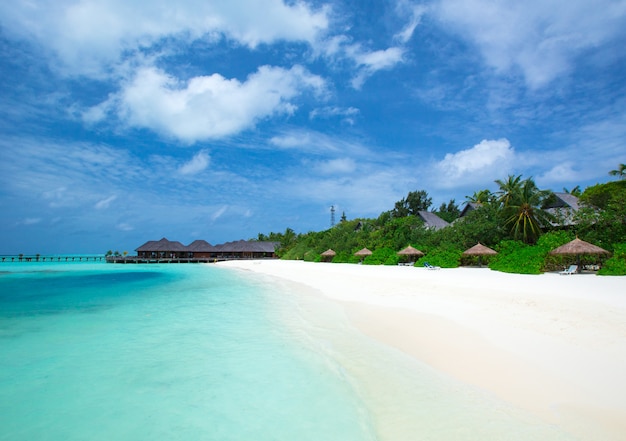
[[0, 0, 329, 76]]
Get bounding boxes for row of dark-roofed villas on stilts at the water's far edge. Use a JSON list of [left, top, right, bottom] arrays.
[[106, 237, 279, 263]]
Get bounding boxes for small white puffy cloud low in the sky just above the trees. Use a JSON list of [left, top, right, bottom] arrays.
[[435, 139, 515, 188]]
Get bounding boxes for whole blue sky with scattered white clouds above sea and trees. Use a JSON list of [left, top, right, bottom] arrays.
[[0, 0, 626, 254]]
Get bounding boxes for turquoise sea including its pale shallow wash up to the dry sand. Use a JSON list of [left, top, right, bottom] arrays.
[[0, 262, 571, 441]]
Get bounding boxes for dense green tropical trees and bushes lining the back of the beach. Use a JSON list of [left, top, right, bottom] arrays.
[[257, 168, 626, 275]]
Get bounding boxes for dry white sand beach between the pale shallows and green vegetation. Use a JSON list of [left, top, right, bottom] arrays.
[[218, 260, 626, 440]]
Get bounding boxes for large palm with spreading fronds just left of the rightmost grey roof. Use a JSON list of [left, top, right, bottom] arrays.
[[504, 178, 554, 243]]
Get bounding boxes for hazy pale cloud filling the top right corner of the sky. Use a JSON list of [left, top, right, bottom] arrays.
[[434, 0, 626, 88]]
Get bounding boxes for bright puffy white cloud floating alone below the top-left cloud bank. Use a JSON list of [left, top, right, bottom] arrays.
[[91, 66, 325, 143]]
